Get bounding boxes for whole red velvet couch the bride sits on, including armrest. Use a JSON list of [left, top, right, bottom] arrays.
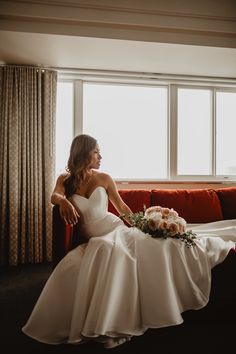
[[53, 187, 236, 319]]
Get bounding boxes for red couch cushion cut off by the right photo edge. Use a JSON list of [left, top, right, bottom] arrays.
[[216, 187, 236, 219]]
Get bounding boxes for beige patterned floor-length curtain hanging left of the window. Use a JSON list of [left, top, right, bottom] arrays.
[[0, 66, 57, 265]]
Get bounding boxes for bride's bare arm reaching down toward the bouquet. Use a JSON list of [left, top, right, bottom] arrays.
[[106, 175, 132, 221]]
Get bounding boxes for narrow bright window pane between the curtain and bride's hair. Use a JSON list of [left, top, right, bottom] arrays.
[[56, 82, 73, 175]]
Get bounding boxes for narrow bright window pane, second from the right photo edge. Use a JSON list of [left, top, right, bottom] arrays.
[[177, 89, 212, 175]]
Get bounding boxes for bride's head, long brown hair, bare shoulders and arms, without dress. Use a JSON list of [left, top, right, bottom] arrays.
[[51, 134, 131, 225]]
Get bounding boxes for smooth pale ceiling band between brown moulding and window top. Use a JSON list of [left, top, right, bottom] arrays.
[[0, 31, 236, 78]]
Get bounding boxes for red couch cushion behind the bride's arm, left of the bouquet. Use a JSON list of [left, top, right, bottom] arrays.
[[108, 189, 151, 215]]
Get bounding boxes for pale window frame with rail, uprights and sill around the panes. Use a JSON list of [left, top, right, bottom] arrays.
[[58, 70, 236, 184]]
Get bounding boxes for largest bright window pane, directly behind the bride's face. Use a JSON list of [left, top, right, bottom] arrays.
[[83, 83, 167, 180]]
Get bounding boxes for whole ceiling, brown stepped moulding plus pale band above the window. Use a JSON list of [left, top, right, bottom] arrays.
[[0, 0, 236, 80]]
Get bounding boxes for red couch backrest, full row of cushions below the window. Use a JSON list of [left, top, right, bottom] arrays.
[[109, 187, 236, 223]]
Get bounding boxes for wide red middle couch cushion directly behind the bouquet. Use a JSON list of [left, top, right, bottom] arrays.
[[151, 189, 223, 223]]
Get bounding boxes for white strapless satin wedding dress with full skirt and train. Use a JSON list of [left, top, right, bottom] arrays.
[[22, 186, 236, 344]]
